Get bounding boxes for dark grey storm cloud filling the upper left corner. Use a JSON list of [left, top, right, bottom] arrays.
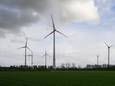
[[0, 0, 49, 35]]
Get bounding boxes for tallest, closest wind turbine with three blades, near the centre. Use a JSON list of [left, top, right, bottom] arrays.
[[44, 16, 67, 68]]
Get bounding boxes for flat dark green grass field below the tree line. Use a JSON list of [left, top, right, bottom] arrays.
[[0, 71, 115, 86]]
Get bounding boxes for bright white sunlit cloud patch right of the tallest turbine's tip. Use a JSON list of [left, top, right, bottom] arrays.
[[60, 0, 99, 22]]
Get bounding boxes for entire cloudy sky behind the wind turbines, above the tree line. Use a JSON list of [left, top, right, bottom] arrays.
[[0, 0, 115, 66]]
